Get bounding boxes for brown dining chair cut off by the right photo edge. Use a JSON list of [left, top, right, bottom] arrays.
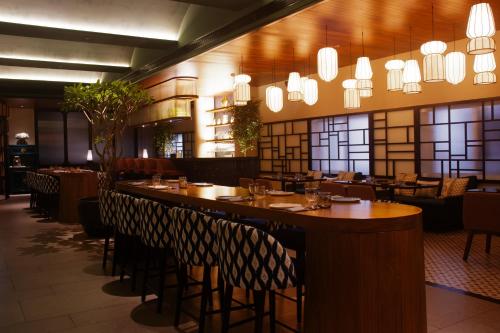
[[463, 192, 500, 261]]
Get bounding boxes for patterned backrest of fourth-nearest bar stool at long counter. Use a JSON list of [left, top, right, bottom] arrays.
[[115, 193, 141, 236]]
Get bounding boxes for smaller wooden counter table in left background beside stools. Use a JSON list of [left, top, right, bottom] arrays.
[[37, 168, 97, 223]]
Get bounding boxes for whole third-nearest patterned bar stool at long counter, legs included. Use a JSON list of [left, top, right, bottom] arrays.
[[140, 199, 173, 313]]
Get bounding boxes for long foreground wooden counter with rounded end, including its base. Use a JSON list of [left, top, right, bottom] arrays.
[[117, 182, 427, 333]]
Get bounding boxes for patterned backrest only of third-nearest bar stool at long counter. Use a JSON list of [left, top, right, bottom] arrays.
[[140, 199, 173, 249]]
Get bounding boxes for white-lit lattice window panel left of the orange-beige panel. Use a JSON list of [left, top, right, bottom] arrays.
[[311, 114, 370, 175]]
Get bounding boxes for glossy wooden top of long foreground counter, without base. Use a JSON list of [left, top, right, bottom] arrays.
[[116, 181, 421, 232]]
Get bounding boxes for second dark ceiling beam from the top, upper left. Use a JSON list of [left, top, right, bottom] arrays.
[[0, 58, 130, 74]]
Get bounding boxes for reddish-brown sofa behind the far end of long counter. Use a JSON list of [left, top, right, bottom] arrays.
[[117, 157, 184, 179]]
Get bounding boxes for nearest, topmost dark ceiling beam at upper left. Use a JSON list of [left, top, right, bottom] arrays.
[[0, 22, 178, 49]]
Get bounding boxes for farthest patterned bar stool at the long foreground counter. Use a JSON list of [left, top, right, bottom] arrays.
[[98, 189, 116, 276]]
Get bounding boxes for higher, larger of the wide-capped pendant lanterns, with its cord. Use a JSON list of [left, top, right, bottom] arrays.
[[420, 4, 446, 82]]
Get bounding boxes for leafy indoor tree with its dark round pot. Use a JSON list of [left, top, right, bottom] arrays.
[[63, 81, 152, 236]]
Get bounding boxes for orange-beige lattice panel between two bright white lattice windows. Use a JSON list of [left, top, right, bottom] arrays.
[[373, 110, 415, 176]]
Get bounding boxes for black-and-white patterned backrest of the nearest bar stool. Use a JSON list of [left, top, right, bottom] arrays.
[[217, 220, 296, 290]]
